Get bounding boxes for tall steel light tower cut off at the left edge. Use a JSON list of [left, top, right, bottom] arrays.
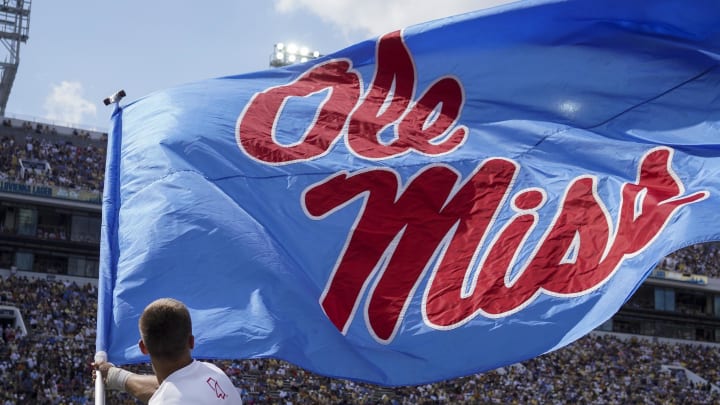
[[0, 0, 30, 117]]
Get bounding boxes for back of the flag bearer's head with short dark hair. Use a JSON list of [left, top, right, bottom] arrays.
[[139, 298, 192, 359]]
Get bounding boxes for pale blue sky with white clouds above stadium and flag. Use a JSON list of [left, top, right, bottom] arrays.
[[6, 0, 509, 131]]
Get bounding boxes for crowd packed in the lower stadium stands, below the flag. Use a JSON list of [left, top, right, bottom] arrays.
[[0, 275, 720, 405]]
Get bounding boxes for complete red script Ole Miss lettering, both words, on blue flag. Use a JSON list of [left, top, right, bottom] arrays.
[[237, 32, 708, 342]]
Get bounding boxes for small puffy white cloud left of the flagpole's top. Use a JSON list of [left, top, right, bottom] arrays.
[[44, 81, 97, 125]]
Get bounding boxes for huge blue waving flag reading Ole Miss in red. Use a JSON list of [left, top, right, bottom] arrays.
[[97, 0, 720, 385]]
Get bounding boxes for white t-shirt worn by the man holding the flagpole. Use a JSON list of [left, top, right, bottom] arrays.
[[148, 360, 242, 405]]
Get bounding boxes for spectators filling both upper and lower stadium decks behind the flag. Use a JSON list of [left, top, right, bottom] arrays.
[[0, 120, 720, 405]]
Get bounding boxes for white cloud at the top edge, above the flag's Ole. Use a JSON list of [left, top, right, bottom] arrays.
[[275, 0, 511, 35]]
